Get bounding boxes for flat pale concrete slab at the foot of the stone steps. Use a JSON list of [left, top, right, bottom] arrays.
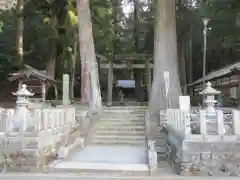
[[52, 145, 149, 173]]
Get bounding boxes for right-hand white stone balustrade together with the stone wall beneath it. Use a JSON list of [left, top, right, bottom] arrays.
[[165, 109, 240, 176]]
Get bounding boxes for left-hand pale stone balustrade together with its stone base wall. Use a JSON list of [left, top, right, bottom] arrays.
[[0, 106, 76, 170]]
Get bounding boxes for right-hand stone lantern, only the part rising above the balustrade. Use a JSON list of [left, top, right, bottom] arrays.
[[199, 82, 221, 114]]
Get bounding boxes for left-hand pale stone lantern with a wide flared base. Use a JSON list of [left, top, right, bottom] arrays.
[[11, 84, 35, 132]]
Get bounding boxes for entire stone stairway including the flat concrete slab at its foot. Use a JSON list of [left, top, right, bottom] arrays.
[[52, 106, 150, 176]]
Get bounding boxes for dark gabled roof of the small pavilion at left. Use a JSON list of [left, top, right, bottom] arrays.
[[7, 64, 56, 82]]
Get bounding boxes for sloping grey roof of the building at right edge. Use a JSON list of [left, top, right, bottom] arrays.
[[188, 62, 240, 86]]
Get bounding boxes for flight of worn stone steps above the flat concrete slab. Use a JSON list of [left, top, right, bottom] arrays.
[[91, 106, 146, 146]]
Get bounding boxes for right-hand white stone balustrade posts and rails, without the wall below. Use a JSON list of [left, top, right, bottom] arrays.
[[166, 109, 240, 141]]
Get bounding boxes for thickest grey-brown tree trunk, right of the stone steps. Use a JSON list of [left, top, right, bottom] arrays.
[[149, 0, 181, 113]]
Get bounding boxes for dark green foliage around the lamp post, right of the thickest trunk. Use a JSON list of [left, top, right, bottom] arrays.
[[177, 0, 240, 79]]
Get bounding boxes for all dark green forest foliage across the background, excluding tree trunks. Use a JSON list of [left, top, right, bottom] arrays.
[[0, 0, 237, 82]]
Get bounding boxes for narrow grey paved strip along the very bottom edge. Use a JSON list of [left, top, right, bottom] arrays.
[[0, 173, 239, 180]]
